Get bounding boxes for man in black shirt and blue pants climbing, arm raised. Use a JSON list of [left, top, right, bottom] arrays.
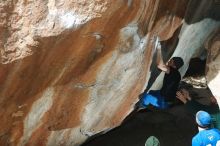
[[140, 39, 184, 109]]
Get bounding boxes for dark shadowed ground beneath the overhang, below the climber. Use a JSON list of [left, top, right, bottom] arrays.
[[82, 106, 197, 146]]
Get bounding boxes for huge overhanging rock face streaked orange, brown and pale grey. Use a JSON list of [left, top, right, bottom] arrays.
[[0, 0, 220, 146]]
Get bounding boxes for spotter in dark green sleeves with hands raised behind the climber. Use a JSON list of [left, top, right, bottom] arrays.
[[176, 88, 220, 129]]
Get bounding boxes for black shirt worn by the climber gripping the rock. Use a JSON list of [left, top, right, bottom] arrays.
[[160, 67, 181, 101]]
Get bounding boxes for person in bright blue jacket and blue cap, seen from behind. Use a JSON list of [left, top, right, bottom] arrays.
[[192, 111, 220, 146]]
